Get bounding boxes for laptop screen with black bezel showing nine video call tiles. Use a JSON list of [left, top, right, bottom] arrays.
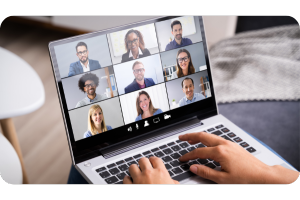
[[49, 16, 216, 162]]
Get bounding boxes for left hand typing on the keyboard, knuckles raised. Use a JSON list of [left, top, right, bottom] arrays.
[[123, 156, 179, 185]]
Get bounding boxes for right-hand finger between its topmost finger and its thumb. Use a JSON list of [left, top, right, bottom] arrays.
[[179, 147, 218, 162]]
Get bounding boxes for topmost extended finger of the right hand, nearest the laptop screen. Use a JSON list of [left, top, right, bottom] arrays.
[[179, 132, 224, 147]]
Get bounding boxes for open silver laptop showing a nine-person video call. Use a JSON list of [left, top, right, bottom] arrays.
[[49, 16, 295, 185]]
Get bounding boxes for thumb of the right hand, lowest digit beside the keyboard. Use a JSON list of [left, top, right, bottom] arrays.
[[190, 165, 225, 184]]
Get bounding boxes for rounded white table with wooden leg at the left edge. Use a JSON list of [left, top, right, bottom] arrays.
[[0, 47, 45, 184]]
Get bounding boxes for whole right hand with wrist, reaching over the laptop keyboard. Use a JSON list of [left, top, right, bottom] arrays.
[[179, 132, 299, 184]]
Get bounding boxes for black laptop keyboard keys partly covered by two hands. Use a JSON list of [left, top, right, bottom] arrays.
[[96, 125, 256, 185]]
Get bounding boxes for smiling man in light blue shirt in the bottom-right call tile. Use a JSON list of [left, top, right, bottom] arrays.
[[179, 77, 205, 106]]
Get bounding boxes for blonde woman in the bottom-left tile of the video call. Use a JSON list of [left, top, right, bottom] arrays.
[[83, 104, 112, 138]]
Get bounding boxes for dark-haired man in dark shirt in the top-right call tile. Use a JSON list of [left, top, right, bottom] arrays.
[[165, 20, 193, 51]]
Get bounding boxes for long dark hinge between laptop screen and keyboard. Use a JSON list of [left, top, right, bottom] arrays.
[[101, 118, 203, 159]]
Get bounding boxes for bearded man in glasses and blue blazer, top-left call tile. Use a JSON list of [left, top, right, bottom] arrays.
[[68, 42, 101, 76]]
